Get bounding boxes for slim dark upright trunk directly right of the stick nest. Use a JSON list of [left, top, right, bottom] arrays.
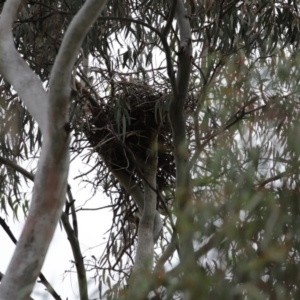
[[169, 0, 195, 263]]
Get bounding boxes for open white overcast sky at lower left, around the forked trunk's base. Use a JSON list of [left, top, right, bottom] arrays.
[[0, 154, 112, 300]]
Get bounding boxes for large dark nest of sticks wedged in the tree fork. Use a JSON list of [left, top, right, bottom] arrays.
[[75, 74, 195, 205]]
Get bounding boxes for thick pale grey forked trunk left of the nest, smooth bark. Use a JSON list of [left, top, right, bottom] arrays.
[[0, 0, 106, 300]]
